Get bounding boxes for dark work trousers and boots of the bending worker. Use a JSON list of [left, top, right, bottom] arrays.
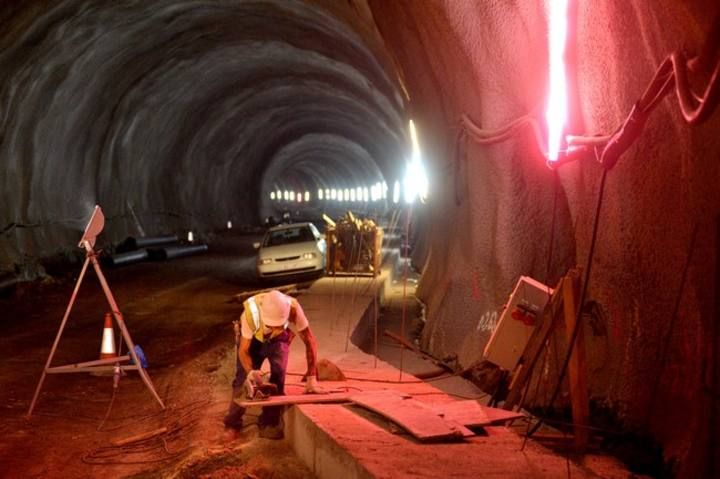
[[224, 330, 291, 428]]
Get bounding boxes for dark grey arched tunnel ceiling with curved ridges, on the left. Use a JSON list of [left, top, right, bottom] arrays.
[[0, 0, 407, 262]]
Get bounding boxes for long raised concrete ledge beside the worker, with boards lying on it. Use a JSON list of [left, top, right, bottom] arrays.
[[278, 272, 627, 479]]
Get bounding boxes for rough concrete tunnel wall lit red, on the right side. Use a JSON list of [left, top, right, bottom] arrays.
[[370, 0, 720, 477]]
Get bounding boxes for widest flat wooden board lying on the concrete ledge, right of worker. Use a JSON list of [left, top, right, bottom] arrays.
[[351, 391, 475, 442]]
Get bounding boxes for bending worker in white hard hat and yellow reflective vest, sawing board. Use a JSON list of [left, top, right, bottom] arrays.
[[224, 290, 323, 439]]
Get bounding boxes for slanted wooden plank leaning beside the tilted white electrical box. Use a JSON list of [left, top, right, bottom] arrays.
[[503, 278, 565, 410]]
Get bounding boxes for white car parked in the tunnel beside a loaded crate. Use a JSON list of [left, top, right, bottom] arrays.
[[253, 222, 327, 278]]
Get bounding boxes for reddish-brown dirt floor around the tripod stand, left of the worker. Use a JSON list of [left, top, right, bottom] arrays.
[[0, 234, 320, 478]]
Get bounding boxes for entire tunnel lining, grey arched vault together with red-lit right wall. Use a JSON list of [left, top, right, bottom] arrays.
[[0, 0, 720, 477]]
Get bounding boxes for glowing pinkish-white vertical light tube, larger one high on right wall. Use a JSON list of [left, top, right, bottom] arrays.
[[545, 0, 568, 161]]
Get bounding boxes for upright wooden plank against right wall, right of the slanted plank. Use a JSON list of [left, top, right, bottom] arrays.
[[563, 274, 590, 452]]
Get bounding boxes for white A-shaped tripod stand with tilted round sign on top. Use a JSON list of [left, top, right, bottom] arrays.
[[27, 206, 165, 417]]
